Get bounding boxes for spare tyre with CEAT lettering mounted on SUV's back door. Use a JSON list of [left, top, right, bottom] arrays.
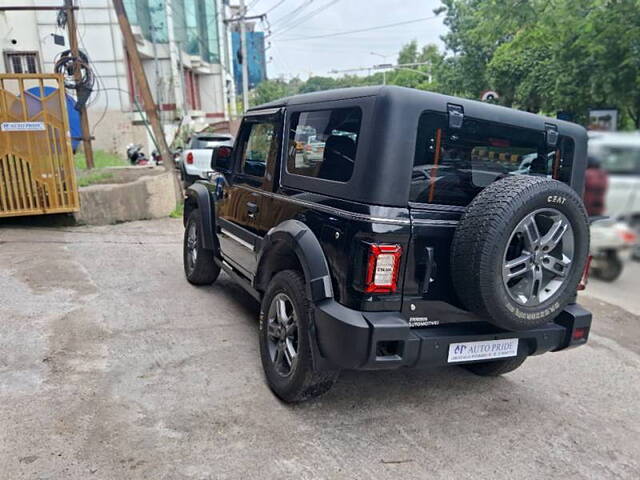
[[451, 175, 589, 330]]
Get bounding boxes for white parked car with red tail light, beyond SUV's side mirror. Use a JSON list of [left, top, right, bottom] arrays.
[[179, 133, 233, 187]]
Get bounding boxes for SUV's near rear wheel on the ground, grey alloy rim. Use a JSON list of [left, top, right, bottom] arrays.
[[260, 270, 338, 403]]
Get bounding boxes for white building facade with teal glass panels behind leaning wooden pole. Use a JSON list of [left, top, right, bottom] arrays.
[[0, 0, 233, 154]]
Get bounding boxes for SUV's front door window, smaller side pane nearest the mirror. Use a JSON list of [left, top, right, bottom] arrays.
[[240, 122, 278, 177]]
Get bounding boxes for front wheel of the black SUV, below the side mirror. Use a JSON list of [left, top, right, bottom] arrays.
[[182, 209, 220, 285]]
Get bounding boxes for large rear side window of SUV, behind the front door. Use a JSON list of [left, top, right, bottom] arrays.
[[287, 107, 362, 182]]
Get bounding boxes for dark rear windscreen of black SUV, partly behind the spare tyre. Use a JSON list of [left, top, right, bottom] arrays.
[[409, 112, 573, 206]]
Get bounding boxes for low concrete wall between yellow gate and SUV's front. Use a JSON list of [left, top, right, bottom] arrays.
[[74, 172, 178, 225]]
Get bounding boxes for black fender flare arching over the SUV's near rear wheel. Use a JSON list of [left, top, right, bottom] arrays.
[[254, 220, 333, 303]]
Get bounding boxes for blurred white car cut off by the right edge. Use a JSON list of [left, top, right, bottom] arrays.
[[589, 132, 640, 260]]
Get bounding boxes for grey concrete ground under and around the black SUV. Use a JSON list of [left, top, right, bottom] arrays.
[[0, 219, 640, 480]]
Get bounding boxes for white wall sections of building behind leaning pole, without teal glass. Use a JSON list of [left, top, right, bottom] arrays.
[[0, 0, 226, 154]]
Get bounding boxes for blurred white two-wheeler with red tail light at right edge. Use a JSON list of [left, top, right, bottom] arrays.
[[590, 220, 637, 282]]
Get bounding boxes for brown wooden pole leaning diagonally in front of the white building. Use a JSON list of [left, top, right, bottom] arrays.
[[113, 0, 174, 169]]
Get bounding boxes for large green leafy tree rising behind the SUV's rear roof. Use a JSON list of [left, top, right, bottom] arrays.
[[437, 0, 640, 128]]
